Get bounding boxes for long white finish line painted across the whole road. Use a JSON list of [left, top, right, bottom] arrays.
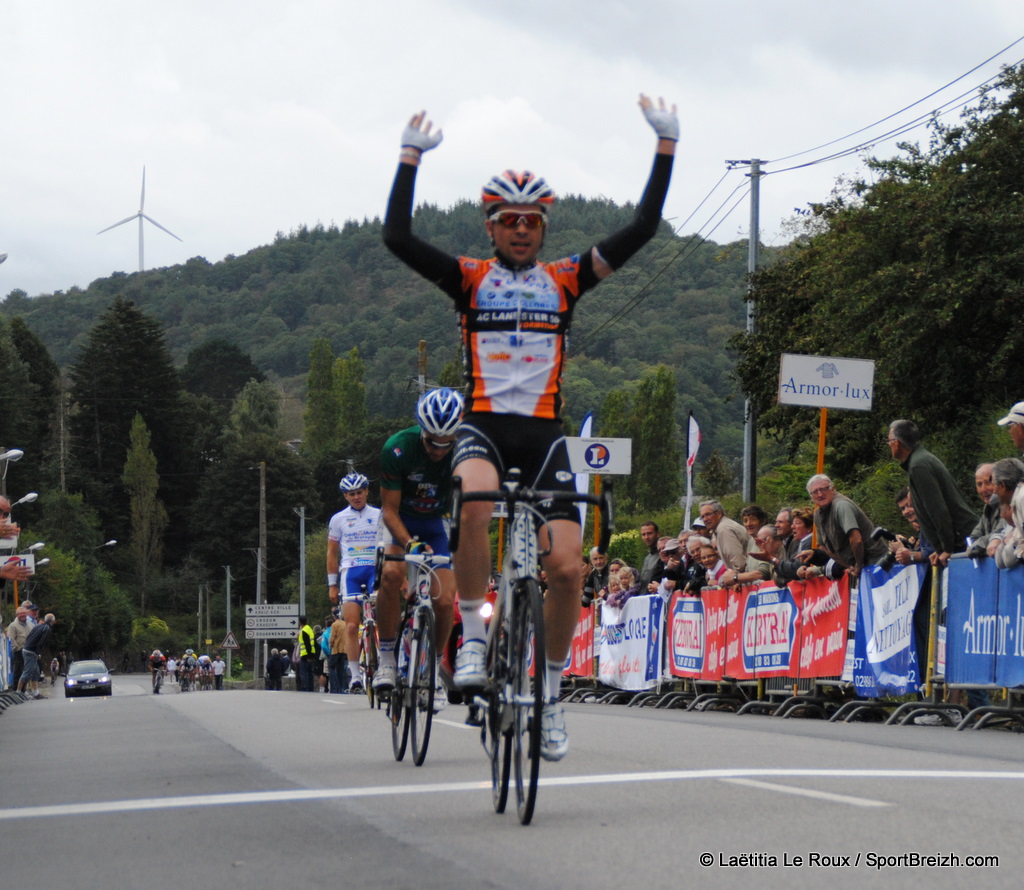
[[0, 768, 1024, 821]]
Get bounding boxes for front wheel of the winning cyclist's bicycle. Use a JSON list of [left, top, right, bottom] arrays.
[[509, 579, 547, 825]]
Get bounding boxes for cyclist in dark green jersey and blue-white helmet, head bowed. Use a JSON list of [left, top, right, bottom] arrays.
[[374, 388, 463, 711]]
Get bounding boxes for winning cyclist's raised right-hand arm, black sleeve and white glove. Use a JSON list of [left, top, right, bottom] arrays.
[[591, 93, 679, 279]]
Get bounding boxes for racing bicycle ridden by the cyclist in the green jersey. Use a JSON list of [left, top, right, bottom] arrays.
[[377, 549, 452, 766]]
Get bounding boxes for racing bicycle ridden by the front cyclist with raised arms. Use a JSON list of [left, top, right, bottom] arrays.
[[449, 469, 614, 825]]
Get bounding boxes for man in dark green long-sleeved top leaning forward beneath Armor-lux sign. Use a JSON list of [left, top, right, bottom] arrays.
[[887, 420, 978, 565]]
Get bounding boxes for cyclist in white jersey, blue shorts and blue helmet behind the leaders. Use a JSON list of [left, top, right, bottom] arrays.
[[327, 473, 381, 692]]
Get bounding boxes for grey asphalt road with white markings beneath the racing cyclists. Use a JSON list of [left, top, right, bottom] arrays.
[[0, 675, 1024, 890]]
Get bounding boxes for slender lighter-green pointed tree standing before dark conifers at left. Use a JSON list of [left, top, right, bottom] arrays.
[[121, 414, 167, 616]]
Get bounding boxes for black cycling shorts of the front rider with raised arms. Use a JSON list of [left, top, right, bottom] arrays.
[[452, 414, 580, 523]]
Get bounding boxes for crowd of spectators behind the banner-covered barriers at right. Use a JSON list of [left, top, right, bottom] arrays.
[[583, 401, 1024, 614]]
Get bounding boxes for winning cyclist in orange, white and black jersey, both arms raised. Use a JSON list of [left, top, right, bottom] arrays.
[[384, 95, 679, 760]]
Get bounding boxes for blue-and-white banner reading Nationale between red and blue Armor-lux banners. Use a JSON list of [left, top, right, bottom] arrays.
[[853, 565, 924, 698]]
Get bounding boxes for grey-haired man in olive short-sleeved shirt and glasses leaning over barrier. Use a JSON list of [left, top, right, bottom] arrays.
[[800, 474, 886, 584]]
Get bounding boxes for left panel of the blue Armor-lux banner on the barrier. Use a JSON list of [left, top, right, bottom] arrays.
[[946, 557, 1006, 685]]
